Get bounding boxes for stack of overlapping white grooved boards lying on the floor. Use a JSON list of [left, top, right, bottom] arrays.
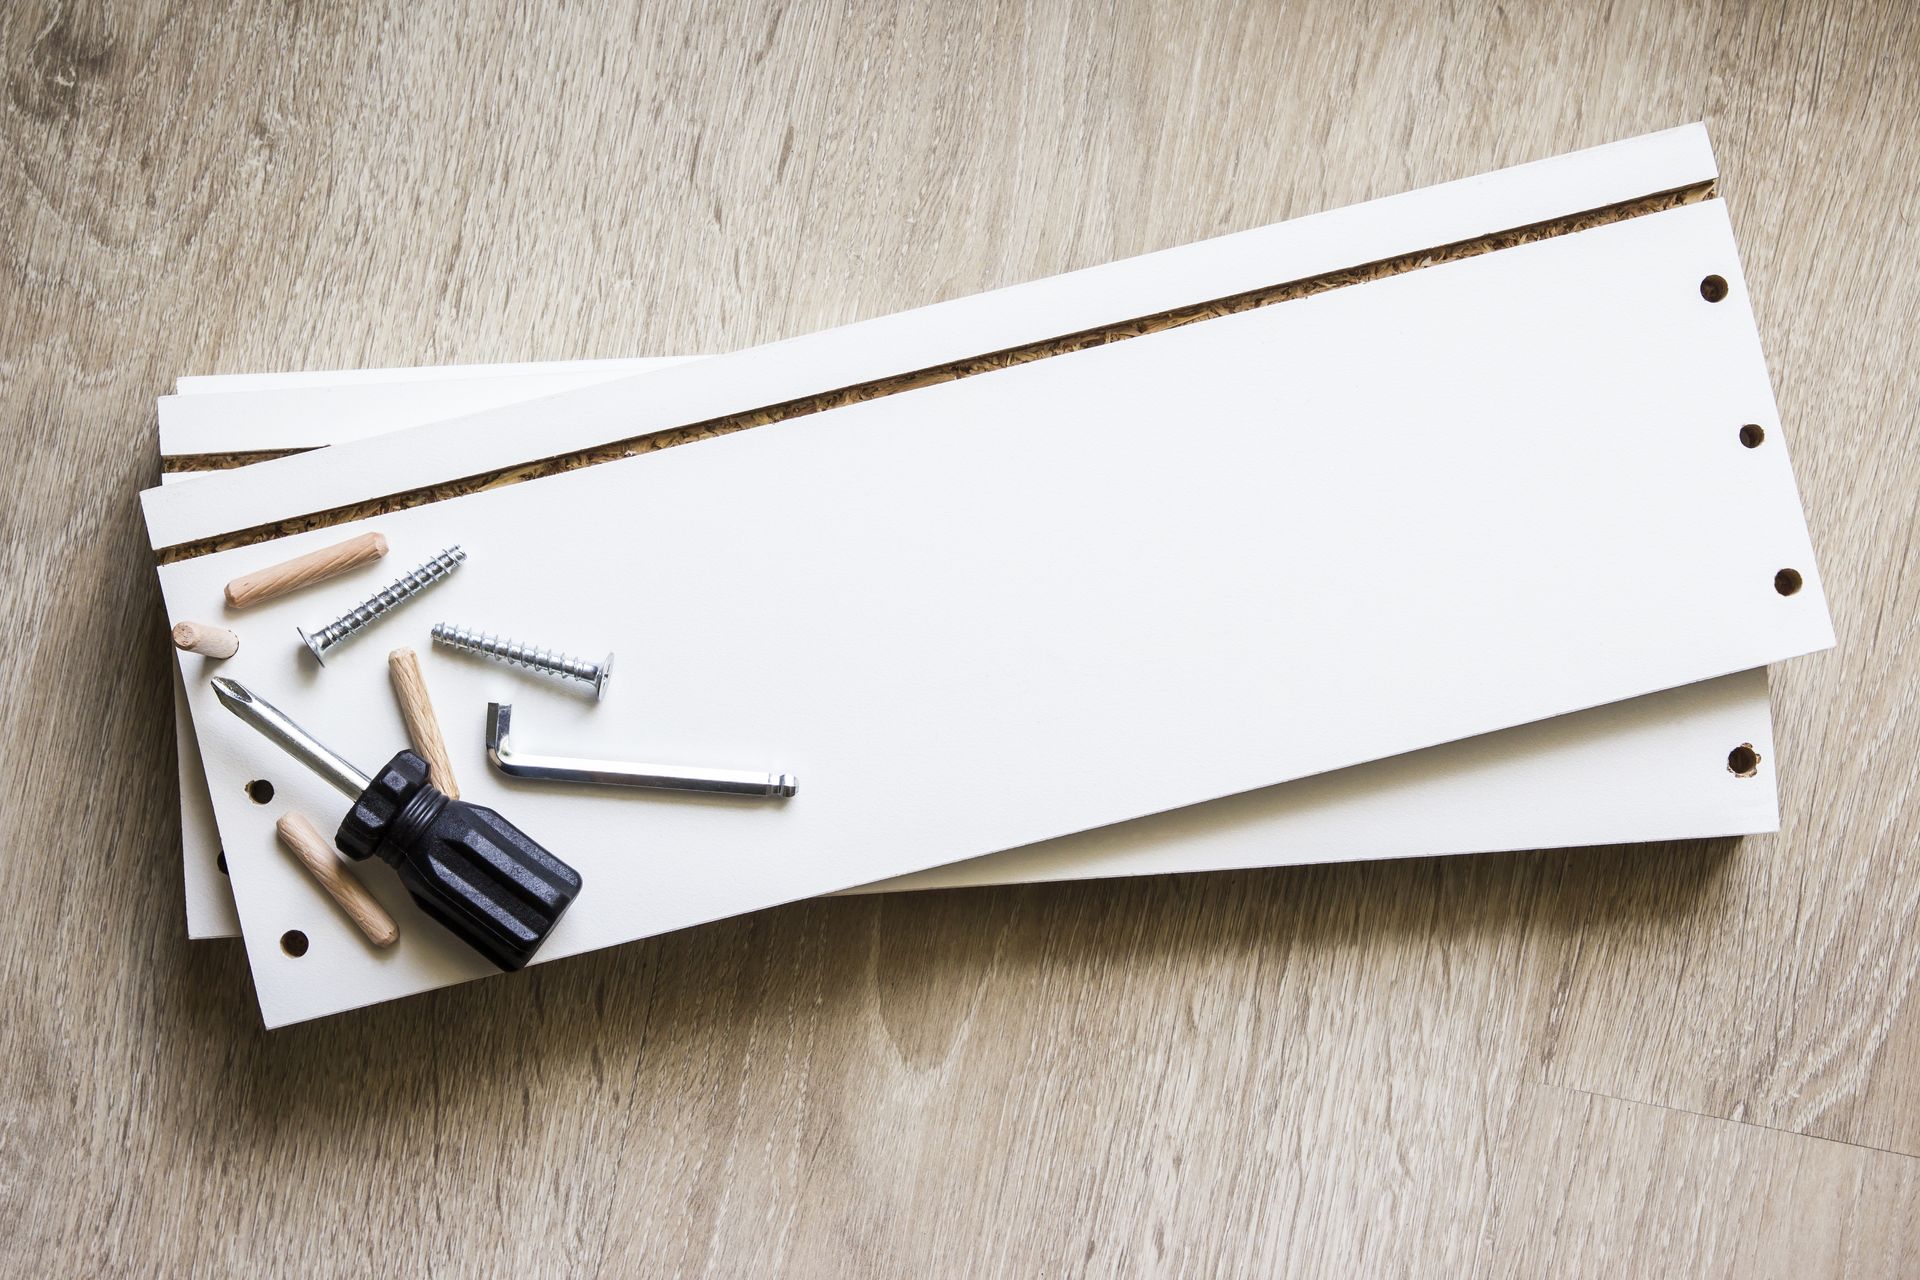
[[142, 125, 1834, 1025]]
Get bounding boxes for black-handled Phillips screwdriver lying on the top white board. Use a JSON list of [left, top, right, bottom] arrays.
[[213, 676, 580, 973]]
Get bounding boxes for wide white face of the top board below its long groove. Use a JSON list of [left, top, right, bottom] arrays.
[[150, 201, 1832, 1025]]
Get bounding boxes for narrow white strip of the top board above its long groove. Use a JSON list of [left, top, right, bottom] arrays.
[[144, 125, 1716, 547]]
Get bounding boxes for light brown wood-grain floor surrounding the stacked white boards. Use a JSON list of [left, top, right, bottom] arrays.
[[0, 0, 1920, 1276]]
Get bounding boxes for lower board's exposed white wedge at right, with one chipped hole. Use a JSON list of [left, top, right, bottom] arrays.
[[864, 670, 1780, 890]]
